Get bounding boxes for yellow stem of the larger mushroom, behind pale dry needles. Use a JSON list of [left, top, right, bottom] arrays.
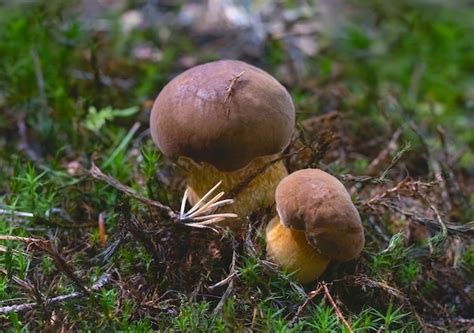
[[179, 155, 288, 227]]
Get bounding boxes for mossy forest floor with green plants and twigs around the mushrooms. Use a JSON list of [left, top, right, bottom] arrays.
[[0, 0, 474, 332]]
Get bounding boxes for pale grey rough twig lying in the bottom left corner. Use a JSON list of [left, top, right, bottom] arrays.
[[0, 273, 112, 315]]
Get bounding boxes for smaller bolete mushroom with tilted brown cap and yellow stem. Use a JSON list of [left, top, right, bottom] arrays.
[[265, 169, 364, 283]]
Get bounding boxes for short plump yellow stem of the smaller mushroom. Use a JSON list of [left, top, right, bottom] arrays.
[[265, 216, 330, 283]]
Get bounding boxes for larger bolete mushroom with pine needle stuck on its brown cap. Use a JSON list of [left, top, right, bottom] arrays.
[[150, 60, 295, 226]]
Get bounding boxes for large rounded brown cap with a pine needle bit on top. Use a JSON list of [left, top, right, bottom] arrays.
[[150, 60, 295, 171]]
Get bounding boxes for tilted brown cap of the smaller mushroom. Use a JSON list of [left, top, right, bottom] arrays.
[[275, 169, 365, 261]]
